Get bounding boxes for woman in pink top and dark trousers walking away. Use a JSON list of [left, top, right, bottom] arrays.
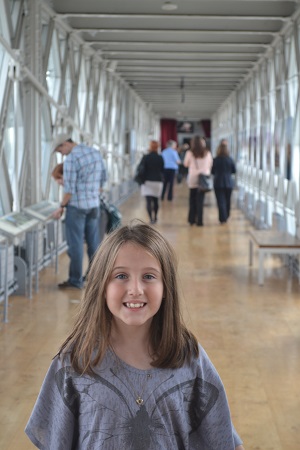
[[183, 136, 213, 227]]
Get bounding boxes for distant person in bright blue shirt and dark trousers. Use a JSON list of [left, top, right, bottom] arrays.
[[161, 139, 181, 202]]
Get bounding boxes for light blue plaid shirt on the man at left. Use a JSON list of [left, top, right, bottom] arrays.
[[64, 144, 106, 209]]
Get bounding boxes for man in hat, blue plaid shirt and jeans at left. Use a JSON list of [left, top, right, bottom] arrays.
[[53, 134, 106, 289]]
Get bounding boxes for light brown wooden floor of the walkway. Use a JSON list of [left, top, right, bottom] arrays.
[[0, 184, 300, 450]]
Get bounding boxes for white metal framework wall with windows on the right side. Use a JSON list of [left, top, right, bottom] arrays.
[[212, 15, 300, 192]]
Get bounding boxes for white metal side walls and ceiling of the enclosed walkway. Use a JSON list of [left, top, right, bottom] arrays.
[[0, 0, 300, 215]]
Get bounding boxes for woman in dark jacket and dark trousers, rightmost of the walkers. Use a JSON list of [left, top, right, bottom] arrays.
[[211, 139, 236, 224]]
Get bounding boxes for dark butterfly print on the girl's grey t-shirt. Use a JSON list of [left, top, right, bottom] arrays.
[[55, 367, 219, 450]]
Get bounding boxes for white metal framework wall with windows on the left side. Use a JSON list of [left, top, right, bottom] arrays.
[[0, 0, 159, 215]]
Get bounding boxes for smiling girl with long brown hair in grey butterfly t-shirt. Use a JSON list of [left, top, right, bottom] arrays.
[[25, 222, 243, 450]]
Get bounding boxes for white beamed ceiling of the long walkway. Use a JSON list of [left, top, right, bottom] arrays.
[[52, 0, 299, 120]]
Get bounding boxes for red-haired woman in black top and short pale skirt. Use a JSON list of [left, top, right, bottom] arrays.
[[141, 141, 164, 224]]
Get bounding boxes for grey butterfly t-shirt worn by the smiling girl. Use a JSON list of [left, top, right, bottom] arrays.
[[25, 347, 242, 450]]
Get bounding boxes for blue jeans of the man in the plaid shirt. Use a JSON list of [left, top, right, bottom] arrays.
[[65, 206, 100, 288]]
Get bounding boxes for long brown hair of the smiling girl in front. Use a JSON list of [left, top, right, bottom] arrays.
[[59, 221, 199, 374]]
